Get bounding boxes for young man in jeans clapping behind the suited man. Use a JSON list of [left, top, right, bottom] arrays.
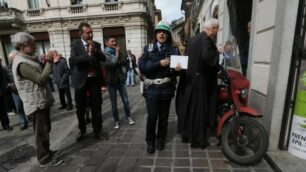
[[104, 36, 135, 130]]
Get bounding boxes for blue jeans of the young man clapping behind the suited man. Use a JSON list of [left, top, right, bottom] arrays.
[[108, 84, 131, 122]]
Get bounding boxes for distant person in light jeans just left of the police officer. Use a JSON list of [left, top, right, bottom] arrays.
[[126, 50, 137, 87]]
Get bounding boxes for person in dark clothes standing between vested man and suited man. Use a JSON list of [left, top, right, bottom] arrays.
[[53, 51, 73, 111]]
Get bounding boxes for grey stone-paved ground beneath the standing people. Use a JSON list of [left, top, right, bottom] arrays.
[[0, 87, 273, 172]]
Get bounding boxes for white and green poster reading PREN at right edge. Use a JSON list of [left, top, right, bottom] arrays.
[[288, 60, 306, 159]]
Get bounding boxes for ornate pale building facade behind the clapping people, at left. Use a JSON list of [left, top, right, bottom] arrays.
[[0, 0, 156, 62]]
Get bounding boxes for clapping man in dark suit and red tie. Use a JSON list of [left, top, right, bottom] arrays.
[[69, 22, 108, 141]]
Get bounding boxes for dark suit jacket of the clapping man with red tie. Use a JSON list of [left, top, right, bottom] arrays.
[[69, 39, 106, 89]]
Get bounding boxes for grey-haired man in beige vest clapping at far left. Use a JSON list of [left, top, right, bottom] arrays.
[[11, 32, 63, 167]]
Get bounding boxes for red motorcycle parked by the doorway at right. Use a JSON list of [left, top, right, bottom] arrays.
[[216, 67, 268, 165]]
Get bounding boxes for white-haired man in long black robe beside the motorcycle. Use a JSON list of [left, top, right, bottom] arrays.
[[176, 19, 219, 148]]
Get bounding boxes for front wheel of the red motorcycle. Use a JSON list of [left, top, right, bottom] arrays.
[[221, 117, 269, 165]]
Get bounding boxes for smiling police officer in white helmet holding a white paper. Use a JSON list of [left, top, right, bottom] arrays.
[[138, 21, 181, 154]]
